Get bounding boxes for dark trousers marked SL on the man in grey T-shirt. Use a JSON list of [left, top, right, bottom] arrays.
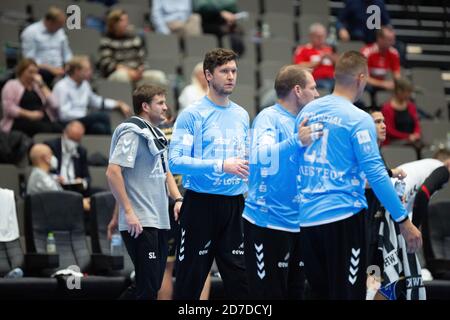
[[121, 227, 167, 300]]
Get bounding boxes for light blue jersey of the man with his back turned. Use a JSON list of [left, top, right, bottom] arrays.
[[295, 95, 407, 226]]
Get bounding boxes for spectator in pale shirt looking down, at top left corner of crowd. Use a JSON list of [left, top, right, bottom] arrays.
[[20, 7, 72, 87]]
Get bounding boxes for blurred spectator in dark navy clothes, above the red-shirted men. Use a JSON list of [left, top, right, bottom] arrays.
[[336, 0, 390, 43]]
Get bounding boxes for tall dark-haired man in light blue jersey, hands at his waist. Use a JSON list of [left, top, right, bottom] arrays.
[[169, 48, 249, 299]]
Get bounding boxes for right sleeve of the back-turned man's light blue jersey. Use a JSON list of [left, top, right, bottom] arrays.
[[350, 115, 408, 222]]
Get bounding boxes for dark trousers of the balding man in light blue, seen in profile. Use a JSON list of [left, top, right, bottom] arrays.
[[244, 219, 305, 300]]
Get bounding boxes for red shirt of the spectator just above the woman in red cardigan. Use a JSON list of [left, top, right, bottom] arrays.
[[361, 43, 400, 80]]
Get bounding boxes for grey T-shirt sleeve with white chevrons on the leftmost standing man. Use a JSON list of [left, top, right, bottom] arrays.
[[109, 132, 139, 168]]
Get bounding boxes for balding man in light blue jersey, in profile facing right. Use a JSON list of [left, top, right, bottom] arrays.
[[242, 65, 320, 299]]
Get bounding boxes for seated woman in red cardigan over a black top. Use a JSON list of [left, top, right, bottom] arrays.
[[381, 78, 421, 145]]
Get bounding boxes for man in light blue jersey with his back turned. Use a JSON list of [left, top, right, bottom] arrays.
[[296, 51, 422, 300]]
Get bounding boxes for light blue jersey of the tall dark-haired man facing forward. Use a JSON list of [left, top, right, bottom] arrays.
[[169, 96, 249, 196]]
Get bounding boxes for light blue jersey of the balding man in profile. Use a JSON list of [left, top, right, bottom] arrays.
[[243, 104, 300, 232]]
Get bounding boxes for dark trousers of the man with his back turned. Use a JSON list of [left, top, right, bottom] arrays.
[[300, 210, 366, 300]]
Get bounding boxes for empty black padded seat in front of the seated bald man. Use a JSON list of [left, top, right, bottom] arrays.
[[25, 191, 128, 299]]
